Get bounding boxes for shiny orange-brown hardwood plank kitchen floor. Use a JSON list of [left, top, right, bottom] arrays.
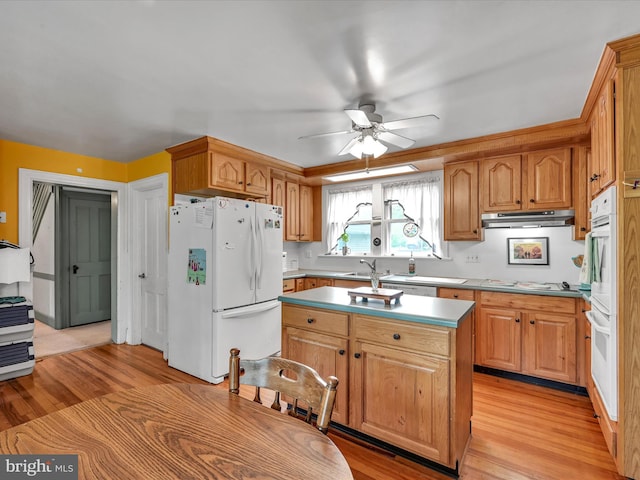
[[0, 344, 623, 480]]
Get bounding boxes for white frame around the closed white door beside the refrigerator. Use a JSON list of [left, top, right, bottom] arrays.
[[127, 173, 169, 352]]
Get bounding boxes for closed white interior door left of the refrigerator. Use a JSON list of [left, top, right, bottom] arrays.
[[129, 174, 168, 352]]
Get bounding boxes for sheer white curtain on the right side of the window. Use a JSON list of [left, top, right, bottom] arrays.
[[383, 175, 443, 255]]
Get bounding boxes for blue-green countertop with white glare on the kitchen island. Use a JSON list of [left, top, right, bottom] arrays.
[[278, 287, 475, 328]]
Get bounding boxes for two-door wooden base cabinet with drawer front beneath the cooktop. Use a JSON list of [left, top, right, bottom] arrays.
[[476, 291, 578, 384]]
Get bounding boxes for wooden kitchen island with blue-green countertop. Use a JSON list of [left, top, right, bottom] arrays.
[[279, 287, 475, 474]]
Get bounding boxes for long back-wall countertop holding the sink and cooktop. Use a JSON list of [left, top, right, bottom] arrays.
[[283, 270, 591, 300]]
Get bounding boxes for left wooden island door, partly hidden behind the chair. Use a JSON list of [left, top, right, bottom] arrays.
[[282, 327, 349, 425]]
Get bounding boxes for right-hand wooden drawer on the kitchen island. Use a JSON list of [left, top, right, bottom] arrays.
[[353, 315, 451, 356]]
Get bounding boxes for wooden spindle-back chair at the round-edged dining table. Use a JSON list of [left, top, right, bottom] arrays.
[[229, 348, 338, 434]]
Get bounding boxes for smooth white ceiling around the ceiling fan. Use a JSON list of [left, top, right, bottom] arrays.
[[0, 0, 640, 167]]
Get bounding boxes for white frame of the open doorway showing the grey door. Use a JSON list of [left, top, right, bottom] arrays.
[[18, 168, 132, 344]]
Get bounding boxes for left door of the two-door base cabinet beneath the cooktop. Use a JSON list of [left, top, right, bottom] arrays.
[[476, 307, 522, 372]]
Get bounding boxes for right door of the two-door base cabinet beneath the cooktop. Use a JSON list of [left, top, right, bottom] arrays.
[[522, 313, 577, 383]]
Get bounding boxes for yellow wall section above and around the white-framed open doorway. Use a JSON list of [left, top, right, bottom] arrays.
[[0, 139, 171, 243]]
